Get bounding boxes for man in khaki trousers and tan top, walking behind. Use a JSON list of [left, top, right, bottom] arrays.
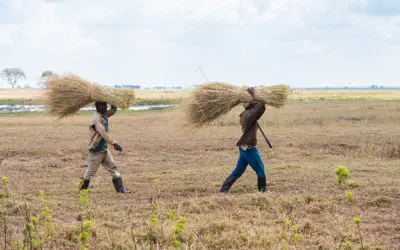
[[80, 101, 132, 193]]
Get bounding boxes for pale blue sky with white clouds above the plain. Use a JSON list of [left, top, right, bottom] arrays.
[[0, 0, 400, 87]]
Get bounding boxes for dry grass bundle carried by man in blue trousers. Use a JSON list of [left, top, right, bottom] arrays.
[[187, 83, 289, 126]]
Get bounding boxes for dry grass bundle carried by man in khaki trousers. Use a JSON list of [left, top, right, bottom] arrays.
[[44, 75, 135, 119]]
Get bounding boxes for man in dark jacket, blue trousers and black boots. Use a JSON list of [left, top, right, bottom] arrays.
[[219, 88, 267, 193]]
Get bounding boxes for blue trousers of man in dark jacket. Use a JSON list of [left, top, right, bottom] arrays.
[[231, 147, 265, 179]]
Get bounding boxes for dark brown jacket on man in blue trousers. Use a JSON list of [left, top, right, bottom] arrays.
[[236, 102, 265, 147]]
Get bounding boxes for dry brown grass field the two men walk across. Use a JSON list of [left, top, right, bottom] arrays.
[[0, 93, 400, 249]]
